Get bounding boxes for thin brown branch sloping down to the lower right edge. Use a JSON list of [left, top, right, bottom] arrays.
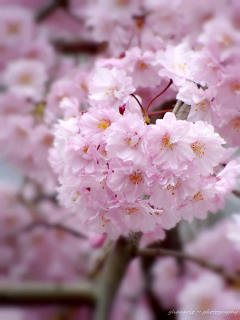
[[136, 249, 240, 283]]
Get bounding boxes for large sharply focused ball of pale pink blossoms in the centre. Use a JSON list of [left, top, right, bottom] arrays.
[[51, 95, 240, 238]]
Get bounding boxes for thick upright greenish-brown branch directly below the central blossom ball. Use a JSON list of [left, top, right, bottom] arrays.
[[94, 232, 142, 320]]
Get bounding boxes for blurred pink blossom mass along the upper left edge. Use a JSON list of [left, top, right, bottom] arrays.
[[0, 5, 79, 194]]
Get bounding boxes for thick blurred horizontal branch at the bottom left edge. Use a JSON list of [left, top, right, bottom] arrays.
[[0, 283, 96, 306]]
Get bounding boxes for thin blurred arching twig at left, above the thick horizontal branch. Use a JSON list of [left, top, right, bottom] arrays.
[[1, 221, 88, 240]]
